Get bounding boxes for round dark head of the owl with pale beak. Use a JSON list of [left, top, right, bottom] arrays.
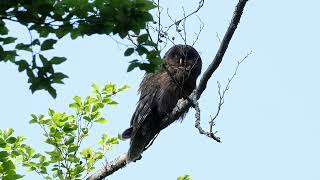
[[165, 44, 202, 75]]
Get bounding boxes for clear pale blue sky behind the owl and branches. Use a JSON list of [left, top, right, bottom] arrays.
[[0, 0, 320, 180]]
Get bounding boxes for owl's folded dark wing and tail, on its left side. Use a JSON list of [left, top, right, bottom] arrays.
[[123, 74, 162, 161]]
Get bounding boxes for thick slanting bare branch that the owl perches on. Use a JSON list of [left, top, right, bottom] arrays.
[[88, 0, 248, 180]]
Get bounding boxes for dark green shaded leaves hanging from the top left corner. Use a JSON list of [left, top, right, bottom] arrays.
[[0, 0, 162, 98]]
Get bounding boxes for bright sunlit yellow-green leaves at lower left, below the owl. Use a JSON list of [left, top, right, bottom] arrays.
[[0, 83, 128, 179]]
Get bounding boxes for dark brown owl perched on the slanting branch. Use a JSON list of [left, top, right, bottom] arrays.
[[122, 45, 202, 162]]
